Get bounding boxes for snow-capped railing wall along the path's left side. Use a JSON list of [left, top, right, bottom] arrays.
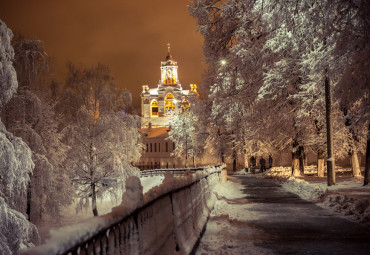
[[21, 166, 225, 255]]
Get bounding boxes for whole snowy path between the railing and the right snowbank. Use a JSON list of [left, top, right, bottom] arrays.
[[196, 176, 370, 255]]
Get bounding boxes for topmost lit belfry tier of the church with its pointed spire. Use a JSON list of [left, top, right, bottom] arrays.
[[161, 43, 179, 85]]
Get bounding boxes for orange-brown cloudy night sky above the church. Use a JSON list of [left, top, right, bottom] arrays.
[[0, 0, 205, 109]]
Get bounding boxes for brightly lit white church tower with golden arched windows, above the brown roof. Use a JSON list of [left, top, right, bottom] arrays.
[[141, 44, 197, 128]]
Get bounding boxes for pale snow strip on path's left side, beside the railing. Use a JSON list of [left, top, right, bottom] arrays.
[[195, 178, 270, 255]]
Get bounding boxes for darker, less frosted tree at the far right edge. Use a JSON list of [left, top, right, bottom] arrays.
[[333, 0, 370, 185]]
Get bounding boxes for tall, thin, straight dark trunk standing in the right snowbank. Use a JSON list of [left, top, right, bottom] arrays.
[[325, 69, 335, 186]]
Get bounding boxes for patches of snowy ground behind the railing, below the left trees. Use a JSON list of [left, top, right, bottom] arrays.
[[35, 175, 164, 243]]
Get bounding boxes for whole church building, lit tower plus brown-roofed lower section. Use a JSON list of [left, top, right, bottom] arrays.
[[137, 44, 198, 170]]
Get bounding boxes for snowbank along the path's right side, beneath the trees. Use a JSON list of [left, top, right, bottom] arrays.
[[258, 167, 370, 227]]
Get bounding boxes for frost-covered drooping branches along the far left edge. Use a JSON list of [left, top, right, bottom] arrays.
[[0, 20, 40, 254]]
